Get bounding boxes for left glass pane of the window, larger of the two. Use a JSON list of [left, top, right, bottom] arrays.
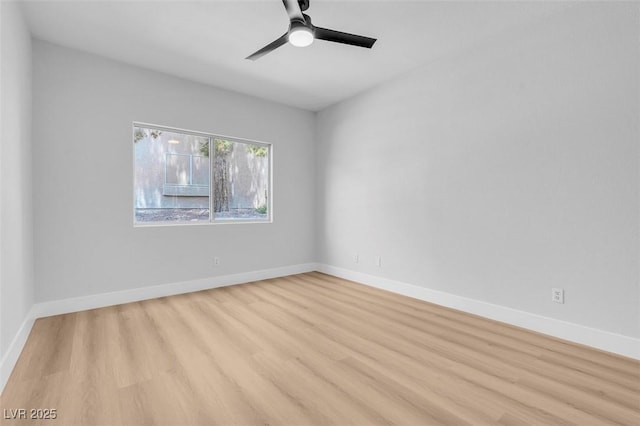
[[134, 127, 211, 223]]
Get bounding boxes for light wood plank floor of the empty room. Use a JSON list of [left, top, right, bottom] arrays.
[[1, 273, 640, 426]]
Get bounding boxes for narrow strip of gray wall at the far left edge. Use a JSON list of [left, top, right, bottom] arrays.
[[0, 1, 34, 358]]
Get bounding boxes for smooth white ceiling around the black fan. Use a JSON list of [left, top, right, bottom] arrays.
[[23, 0, 568, 111]]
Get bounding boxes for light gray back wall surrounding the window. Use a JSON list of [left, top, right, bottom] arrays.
[[33, 41, 315, 302]]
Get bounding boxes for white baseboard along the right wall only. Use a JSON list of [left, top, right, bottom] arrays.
[[318, 264, 640, 359]]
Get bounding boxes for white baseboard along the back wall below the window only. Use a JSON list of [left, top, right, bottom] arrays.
[[33, 263, 317, 318]]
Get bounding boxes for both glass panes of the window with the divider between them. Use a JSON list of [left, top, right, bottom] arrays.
[[133, 124, 271, 225]]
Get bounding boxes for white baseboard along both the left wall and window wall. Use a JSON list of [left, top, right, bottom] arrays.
[[0, 263, 317, 394]]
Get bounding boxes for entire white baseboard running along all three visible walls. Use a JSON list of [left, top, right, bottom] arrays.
[[0, 263, 640, 394]]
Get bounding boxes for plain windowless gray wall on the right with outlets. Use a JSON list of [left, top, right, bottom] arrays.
[[317, 3, 640, 337]]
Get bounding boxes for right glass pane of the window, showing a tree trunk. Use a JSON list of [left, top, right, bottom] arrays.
[[213, 138, 270, 220]]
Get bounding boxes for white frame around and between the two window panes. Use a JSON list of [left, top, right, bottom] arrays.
[[131, 121, 273, 228]]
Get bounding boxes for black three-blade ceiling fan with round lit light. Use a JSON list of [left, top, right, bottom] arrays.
[[246, 0, 376, 61]]
